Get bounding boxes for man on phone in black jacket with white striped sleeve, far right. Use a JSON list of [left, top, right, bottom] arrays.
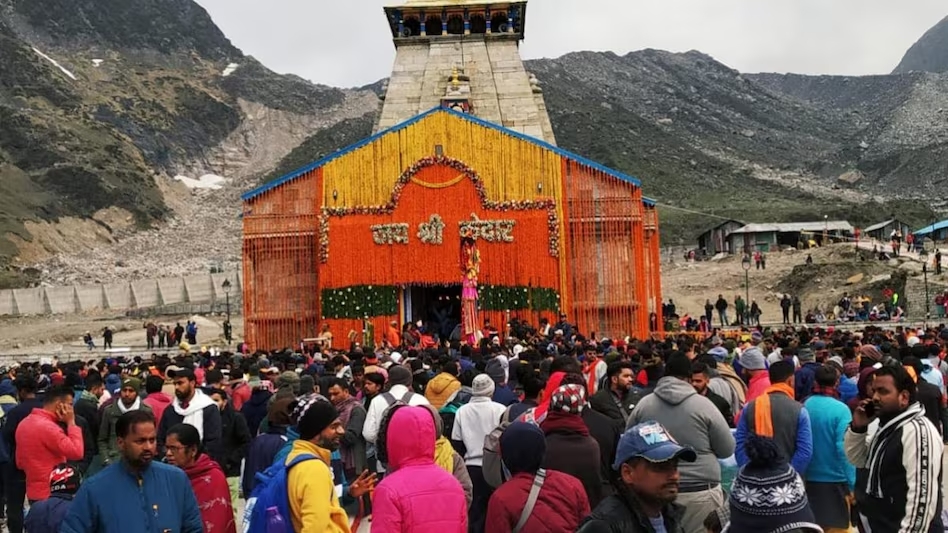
[[844, 366, 944, 533]]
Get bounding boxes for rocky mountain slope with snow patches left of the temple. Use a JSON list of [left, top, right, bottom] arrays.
[[0, 0, 378, 286]]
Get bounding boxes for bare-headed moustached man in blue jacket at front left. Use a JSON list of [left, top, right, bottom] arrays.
[[59, 410, 204, 533]]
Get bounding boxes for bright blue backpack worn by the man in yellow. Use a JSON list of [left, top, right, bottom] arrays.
[[243, 454, 322, 533]]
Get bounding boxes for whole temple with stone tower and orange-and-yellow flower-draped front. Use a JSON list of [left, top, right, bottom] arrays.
[[242, 0, 662, 349]]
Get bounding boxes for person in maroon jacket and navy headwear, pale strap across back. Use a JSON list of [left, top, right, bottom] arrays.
[[485, 423, 589, 533]]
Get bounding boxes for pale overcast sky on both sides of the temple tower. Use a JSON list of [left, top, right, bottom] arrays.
[[197, 0, 948, 86]]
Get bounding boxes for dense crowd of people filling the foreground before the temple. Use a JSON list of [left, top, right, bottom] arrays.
[[0, 316, 948, 533]]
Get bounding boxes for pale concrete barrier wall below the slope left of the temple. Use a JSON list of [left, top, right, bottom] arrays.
[[0, 272, 242, 316]]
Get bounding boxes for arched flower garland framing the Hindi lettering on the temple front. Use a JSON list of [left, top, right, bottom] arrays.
[[319, 156, 560, 263]]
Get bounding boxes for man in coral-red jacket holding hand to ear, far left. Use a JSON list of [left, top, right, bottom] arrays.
[[16, 387, 85, 504]]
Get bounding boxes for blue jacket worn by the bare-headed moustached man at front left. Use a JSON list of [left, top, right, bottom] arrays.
[[59, 461, 204, 533]]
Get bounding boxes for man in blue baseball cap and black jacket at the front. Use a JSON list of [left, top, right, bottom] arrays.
[[578, 420, 698, 533]]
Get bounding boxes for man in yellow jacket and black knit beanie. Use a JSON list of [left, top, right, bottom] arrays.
[[286, 395, 374, 533]]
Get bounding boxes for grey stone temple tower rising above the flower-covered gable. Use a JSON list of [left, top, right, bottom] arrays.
[[375, 0, 556, 144]]
